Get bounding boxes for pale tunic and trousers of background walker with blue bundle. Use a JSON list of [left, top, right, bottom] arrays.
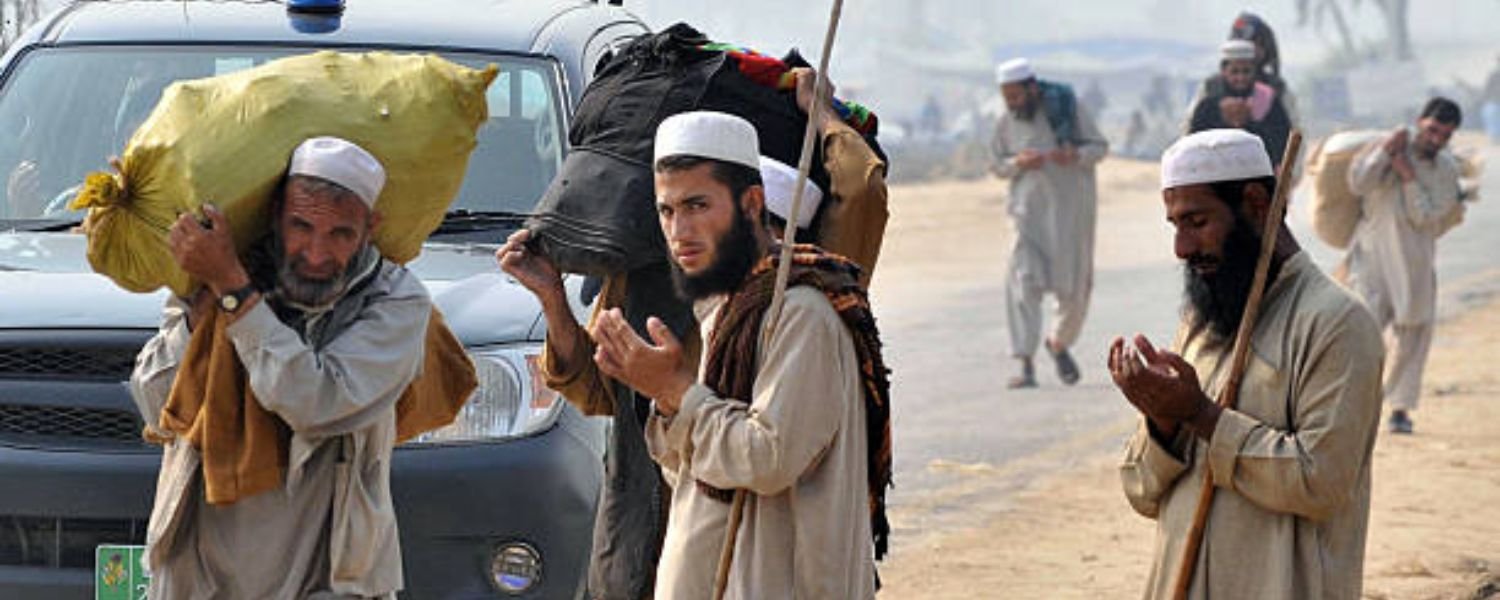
[[990, 100, 1109, 357]]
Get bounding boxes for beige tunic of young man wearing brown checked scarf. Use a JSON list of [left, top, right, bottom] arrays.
[[647, 287, 875, 600]]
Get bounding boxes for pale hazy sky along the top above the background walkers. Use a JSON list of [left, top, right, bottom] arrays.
[[626, 0, 1500, 118]]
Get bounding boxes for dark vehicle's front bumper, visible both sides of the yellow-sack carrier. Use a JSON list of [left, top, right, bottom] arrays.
[[0, 407, 605, 600]]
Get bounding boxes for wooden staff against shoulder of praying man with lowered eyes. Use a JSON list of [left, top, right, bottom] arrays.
[[1172, 129, 1302, 600]]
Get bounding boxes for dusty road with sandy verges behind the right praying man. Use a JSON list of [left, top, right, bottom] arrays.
[[872, 141, 1500, 600]]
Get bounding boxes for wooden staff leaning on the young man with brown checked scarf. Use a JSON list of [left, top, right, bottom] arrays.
[[714, 0, 843, 600]]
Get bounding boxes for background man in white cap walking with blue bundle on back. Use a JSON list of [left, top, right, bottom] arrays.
[[990, 59, 1109, 389]]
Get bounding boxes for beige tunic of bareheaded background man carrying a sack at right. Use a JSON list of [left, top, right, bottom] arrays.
[[1347, 131, 1464, 326]]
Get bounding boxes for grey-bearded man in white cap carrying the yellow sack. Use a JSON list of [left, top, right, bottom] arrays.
[[131, 138, 437, 599]]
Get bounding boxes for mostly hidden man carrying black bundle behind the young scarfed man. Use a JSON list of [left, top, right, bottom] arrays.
[[495, 68, 887, 600]]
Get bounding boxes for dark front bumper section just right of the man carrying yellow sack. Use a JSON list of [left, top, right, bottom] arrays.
[[392, 405, 605, 600]]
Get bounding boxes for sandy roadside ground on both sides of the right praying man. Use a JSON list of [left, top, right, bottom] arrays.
[[881, 302, 1500, 600]]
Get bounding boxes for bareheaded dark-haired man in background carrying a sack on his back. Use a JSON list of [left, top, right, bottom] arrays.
[[1346, 98, 1464, 434]]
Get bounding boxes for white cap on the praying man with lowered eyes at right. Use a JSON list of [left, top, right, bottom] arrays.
[[1161, 129, 1274, 191]]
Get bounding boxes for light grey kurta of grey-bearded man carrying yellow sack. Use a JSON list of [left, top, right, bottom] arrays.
[[131, 263, 432, 599]]
